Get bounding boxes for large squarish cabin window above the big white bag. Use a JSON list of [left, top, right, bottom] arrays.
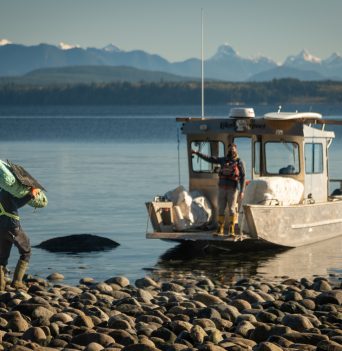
[[265, 142, 299, 175]]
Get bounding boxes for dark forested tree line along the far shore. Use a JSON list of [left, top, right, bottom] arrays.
[[0, 79, 342, 105]]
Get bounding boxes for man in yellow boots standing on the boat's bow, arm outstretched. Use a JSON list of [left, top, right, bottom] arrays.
[[192, 144, 245, 236]]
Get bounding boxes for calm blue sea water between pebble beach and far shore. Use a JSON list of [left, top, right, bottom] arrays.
[[0, 105, 342, 284]]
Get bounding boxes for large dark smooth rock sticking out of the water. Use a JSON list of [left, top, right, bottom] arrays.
[[35, 234, 120, 252]]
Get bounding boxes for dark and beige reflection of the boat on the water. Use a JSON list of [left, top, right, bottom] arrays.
[[152, 237, 342, 283]]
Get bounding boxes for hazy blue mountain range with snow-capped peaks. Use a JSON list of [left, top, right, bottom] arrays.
[[0, 39, 342, 82]]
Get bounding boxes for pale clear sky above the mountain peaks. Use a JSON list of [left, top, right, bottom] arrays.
[[0, 0, 342, 63]]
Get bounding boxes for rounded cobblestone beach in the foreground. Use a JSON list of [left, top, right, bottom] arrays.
[[0, 273, 342, 351]]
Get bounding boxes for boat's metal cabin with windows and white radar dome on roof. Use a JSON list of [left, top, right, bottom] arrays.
[[182, 108, 335, 217]]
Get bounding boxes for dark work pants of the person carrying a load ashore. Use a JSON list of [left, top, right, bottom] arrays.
[[0, 227, 31, 266]]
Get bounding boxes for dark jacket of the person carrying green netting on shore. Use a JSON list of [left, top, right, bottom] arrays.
[[0, 189, 33, 230]]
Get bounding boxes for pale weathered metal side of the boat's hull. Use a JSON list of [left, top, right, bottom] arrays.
[[244, 201, 342, 247]]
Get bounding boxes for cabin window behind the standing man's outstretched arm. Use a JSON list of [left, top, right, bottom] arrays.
[[191, 140, 225, 173]]
